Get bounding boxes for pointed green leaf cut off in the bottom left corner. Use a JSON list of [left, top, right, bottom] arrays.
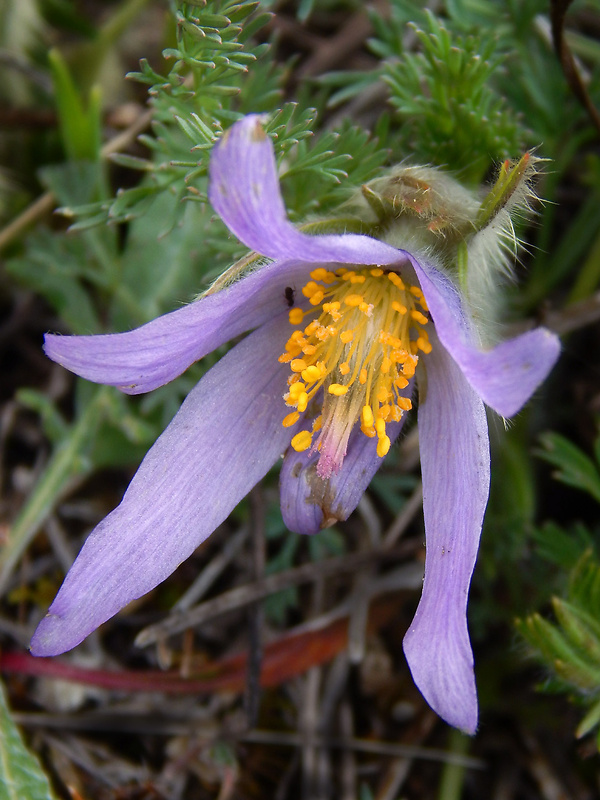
[[0, 685, 56, 800]]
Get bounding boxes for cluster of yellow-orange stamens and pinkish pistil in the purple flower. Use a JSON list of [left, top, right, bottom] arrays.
[[279, 267, 431, 478]]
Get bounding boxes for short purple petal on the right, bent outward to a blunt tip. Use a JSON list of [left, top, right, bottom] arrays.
[[411, 256, 560, 417]]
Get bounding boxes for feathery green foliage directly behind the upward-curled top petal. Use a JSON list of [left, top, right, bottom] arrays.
[[68, 0, 387, 230]]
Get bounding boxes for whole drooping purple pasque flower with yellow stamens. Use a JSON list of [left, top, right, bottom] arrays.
[[31, 116, 559, 732]]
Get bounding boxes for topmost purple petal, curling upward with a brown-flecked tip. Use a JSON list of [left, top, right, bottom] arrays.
[[208, 115, 407, 266]]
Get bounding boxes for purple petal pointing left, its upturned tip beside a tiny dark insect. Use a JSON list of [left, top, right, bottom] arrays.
[[44, 260, 316, 394]]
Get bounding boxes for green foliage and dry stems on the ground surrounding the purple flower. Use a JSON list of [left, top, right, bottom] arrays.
[[0, 0, 600, 800]]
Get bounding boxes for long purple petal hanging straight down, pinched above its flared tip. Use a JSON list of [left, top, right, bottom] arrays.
[[404, 332, 490, 733]]
